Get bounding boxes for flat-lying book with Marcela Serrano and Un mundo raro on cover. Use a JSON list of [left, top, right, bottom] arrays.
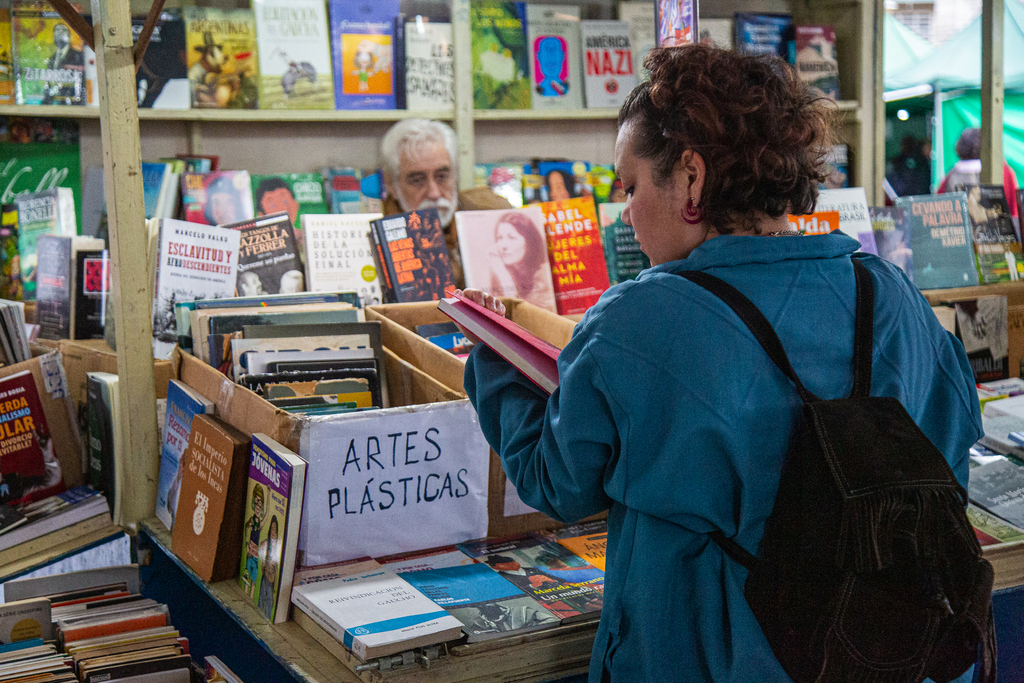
[[458, 533, 604, 624]]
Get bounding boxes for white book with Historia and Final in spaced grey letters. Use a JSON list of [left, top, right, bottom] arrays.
[[301, 213, 382, 305]]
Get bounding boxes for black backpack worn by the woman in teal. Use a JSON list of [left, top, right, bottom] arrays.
[[680, 258, 995, 683]]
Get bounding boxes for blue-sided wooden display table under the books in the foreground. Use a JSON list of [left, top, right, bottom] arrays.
[[138, 518, 597, 683]]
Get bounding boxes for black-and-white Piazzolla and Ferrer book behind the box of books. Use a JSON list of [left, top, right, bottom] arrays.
[[221, 211, 306, 297]]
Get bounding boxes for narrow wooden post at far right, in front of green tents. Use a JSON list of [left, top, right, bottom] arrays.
[[981, 0, 1005, 185]]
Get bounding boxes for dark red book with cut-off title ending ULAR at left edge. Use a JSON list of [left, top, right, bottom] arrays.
[[0, 371, 53, 479]]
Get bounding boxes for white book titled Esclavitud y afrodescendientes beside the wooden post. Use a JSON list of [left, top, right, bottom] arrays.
[[153, 218, 242, 358]]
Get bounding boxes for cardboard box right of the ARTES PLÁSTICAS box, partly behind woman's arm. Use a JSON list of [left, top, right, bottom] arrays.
[[366, 299, 575, 537]]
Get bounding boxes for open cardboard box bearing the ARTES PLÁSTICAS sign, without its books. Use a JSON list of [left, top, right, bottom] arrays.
[[175, 348, 490, 566]]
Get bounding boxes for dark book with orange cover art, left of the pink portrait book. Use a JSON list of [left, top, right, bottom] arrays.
[[370, 209, 455, 303]]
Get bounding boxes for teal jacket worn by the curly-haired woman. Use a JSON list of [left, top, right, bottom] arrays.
[[465, 234, 982, 683]]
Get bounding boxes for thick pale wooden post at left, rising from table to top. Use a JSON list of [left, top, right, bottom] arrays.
[[92, 0, 160, 523]]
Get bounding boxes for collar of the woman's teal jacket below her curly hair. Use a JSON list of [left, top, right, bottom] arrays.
[[637, 231, 860, 280]]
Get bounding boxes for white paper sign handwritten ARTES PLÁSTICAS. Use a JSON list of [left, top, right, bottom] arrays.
[[299, 400, 489, 566]]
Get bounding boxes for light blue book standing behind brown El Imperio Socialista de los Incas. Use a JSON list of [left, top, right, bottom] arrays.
[[157, 380, 213, 528]]
